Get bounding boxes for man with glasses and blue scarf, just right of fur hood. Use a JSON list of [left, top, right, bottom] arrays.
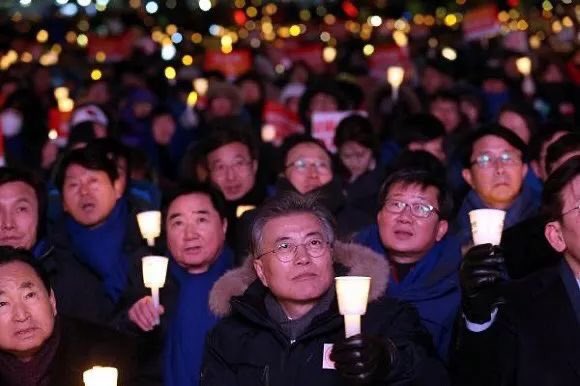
[[355, 168, 461, 359]]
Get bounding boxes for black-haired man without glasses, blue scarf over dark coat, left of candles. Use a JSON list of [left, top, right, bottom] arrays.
[[45, 147, 146, 324]]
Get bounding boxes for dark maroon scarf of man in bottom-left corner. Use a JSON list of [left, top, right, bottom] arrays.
[[0, 322, 60, 386]]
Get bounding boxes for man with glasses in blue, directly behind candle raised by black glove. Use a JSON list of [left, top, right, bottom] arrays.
[[455, 124, 539, 244]]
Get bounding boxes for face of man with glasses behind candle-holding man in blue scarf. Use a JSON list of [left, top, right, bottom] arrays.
[[207, 142, 258, 201]]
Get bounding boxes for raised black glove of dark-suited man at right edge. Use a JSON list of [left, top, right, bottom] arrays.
[[459, 244, 507, 324]]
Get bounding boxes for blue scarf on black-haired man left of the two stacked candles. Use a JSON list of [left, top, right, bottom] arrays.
[[66, 197, 129, 303]]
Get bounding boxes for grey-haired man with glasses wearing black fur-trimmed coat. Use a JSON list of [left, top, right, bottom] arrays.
[[201, 193, 446, 386]]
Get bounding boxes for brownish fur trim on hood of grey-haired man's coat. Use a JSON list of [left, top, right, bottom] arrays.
[[209, 241, 389, 317]]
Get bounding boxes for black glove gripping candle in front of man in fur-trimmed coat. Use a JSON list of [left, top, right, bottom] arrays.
[[330, 334, 396, 385]]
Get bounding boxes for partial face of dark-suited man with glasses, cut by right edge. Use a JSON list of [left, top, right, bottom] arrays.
[[544, 176, 580, 278]]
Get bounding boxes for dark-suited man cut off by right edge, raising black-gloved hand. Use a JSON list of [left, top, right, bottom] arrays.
[[454, 156, 580, 386]]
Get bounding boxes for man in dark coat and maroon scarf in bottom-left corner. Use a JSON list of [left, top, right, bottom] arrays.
[[0, 246, 135, 386]]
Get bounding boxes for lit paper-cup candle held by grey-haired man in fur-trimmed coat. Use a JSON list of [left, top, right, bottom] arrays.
[[335, 276, 371, 338]]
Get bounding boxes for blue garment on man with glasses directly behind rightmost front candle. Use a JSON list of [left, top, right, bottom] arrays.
[[453, 184, 540, 244]]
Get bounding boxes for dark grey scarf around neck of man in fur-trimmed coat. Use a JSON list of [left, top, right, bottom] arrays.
[[264, 287, 335, 342]]
